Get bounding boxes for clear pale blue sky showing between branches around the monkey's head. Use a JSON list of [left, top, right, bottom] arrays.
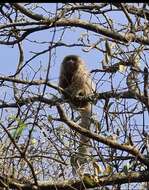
[[0, 3, 148, 126]]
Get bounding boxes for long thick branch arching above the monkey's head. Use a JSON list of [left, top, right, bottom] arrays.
[[0, 17, 149, 45]]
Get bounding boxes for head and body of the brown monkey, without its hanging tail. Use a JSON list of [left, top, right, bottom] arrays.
[[59, 55, 95, 108]]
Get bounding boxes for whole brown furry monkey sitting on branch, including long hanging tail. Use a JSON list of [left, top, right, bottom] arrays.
[[59, 55, 95, 175]]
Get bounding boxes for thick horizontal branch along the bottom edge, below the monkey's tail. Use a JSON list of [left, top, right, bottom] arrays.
[[0, 171, 149, 190]]
